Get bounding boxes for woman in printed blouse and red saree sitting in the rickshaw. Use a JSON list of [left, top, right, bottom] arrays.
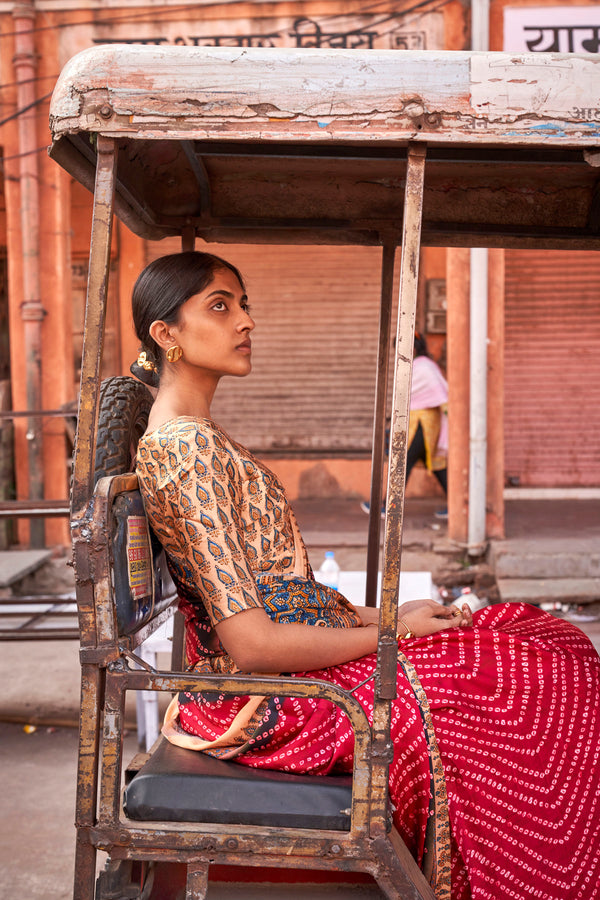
[[133, 252, 600, 900]]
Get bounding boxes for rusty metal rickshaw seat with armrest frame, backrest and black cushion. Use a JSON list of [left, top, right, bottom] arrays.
[[82, 438, 433, 900]]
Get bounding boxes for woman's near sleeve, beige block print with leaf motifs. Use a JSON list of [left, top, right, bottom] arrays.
[[161, 428, 262, 625]]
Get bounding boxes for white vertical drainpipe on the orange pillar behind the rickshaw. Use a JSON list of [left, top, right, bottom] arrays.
[[467, 0, 490, 556]]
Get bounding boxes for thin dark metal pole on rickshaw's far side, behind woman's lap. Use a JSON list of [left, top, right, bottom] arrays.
[[366, 241, 396, 606]]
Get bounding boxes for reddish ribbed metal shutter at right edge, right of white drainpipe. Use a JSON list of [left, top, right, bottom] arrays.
[[505, 250, 600, 487]]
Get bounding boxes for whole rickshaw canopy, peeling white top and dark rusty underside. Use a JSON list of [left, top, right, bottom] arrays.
[[50, 45, 600, 249]]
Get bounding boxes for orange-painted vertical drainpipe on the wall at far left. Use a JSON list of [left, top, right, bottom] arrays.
[[13, 0, 45, 547]]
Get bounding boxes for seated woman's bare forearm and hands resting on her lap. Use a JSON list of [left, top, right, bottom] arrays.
[[216, 600, 472, 673]]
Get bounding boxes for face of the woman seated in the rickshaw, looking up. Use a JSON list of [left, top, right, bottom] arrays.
[[165, 269, 254, 377]]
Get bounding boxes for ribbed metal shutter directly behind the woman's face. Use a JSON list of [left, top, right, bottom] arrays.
[[148, 240, 390, 456]]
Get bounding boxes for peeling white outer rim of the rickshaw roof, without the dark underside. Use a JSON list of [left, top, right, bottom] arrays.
[[50, 45, 600, 146]]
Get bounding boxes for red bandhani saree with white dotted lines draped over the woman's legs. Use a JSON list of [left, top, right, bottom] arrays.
[[169, 604, 600, 900]]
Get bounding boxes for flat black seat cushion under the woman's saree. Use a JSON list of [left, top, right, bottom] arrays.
[[124, 741, 352, 831]]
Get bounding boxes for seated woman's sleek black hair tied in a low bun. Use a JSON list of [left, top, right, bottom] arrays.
[[131, 250, 245, 385]]
